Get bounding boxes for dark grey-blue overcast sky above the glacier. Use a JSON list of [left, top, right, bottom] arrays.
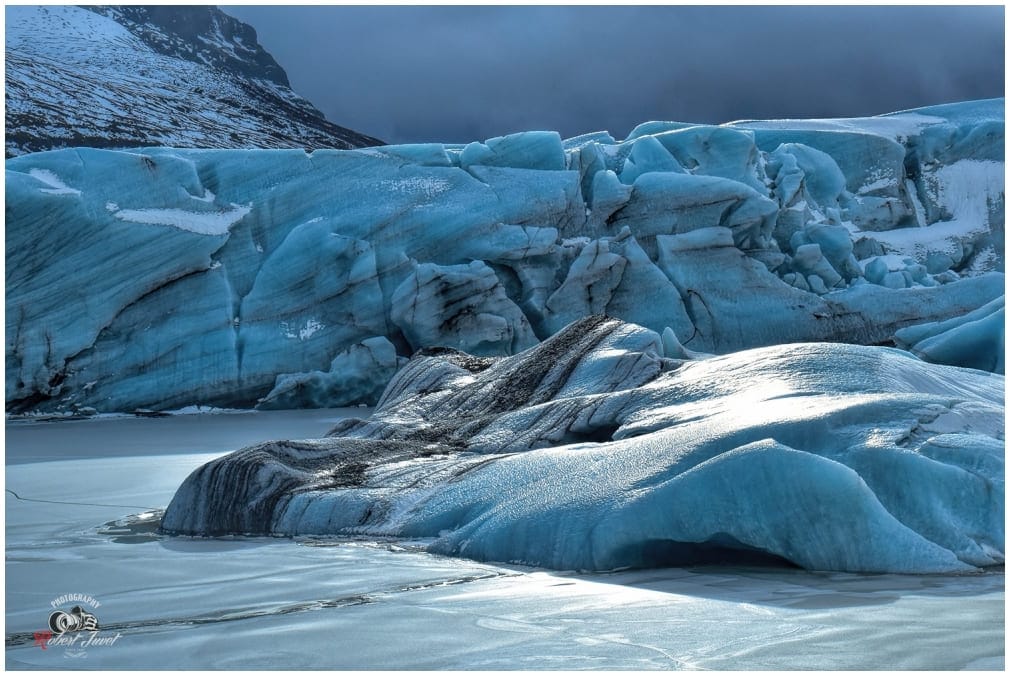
[[222, 6, 1004, 142]]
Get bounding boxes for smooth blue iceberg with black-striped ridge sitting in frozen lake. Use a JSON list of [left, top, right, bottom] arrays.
[[162, 315, 1005, 573]]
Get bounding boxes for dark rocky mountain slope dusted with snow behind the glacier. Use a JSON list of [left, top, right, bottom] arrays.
[[5, 5, 381, 157]]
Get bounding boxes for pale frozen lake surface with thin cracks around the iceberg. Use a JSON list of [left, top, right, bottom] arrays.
[[6, 409, 1005, 670]]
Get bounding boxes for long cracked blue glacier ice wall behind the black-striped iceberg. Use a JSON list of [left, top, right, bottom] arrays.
[[6, 99, 1004, 411]]
